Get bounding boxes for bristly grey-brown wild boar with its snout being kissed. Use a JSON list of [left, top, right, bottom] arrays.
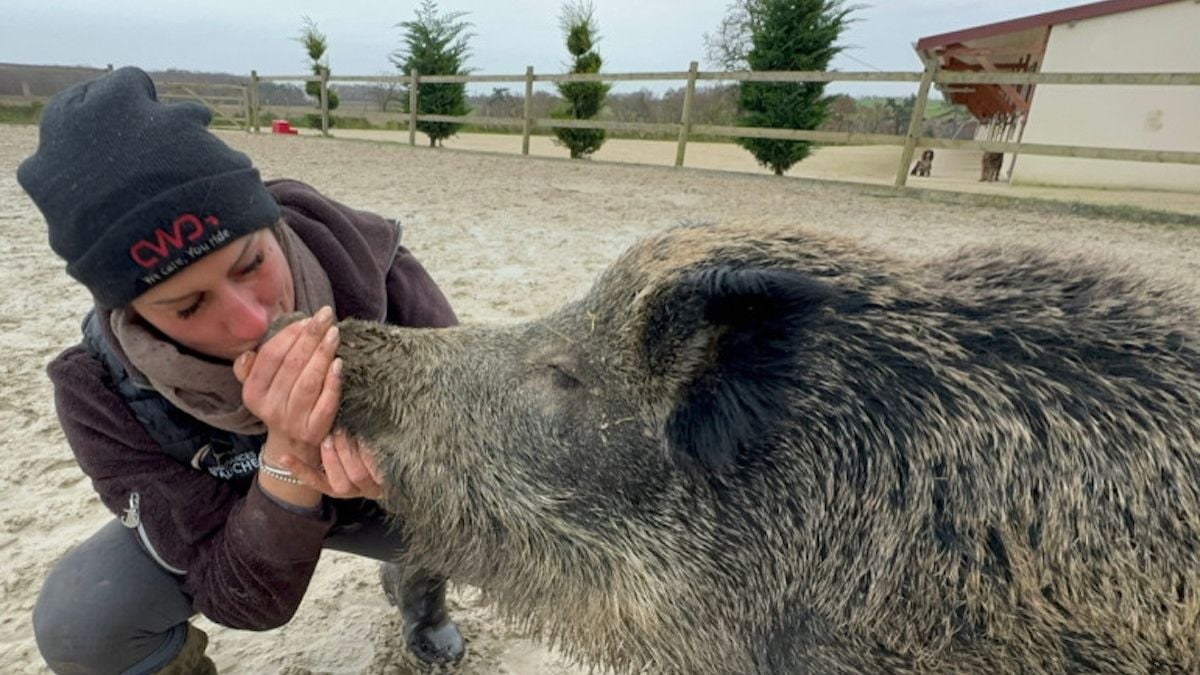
[[328, 226, 1200, 674]]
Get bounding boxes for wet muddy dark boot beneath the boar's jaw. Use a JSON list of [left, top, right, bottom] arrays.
[[379, 562, 466, 665]]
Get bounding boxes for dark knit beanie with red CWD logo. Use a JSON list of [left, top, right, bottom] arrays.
[[17, 67, 280, 309]]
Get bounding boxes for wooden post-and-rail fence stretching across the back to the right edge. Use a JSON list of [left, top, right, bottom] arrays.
[[247, 59, 1200, 187]]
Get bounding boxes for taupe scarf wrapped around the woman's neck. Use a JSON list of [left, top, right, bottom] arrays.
[[109, 219, 337, 435]]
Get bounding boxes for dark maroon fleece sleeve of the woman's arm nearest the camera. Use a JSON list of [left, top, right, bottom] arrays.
[[47, 346, 332, 631]]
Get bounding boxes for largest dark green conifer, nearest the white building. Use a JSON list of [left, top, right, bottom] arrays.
[[738, 0, 856, 175]]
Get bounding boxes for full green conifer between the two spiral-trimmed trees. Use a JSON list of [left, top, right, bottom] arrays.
[[390, 0, 475, 148]]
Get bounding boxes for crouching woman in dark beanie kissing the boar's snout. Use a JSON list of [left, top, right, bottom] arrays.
[[18, 68, 462, 673]]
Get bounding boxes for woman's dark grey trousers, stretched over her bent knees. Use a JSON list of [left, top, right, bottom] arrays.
[[34, 506, 436, 675]]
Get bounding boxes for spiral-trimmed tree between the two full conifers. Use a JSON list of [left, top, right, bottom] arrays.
[[551, 0, 611, 160]]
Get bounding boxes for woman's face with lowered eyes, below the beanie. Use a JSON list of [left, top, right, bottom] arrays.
[[131, 228, 295, 360]]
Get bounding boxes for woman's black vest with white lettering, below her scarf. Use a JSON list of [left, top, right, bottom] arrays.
[[83, 310, 266, 482]]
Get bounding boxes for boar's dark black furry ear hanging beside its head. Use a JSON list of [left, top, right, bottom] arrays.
[[643, 268, 834, 471]]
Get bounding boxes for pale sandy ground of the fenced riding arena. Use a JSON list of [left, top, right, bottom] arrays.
[[0, 121, 1200, 675]]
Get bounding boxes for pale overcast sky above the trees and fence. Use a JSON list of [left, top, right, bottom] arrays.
[[0, 0, 1082, 95]]
